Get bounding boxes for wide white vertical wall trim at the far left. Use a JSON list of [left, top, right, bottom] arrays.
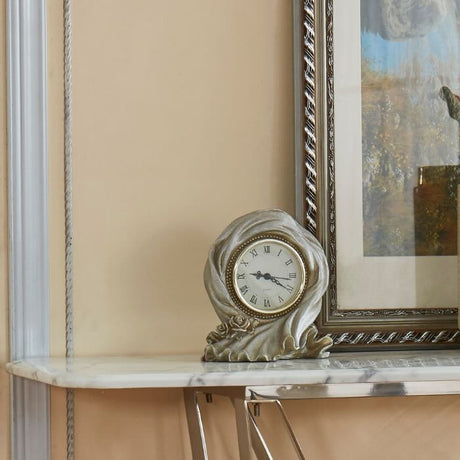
[[7, 0, 50, 460]]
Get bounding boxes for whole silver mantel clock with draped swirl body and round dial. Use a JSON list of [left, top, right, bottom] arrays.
[[203, 209, 332, 361]]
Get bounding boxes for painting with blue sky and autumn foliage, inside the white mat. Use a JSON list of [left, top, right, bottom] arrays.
[[360, 0, 460, 257]]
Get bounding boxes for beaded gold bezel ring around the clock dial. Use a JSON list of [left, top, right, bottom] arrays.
[[225, 232, 309, 319]]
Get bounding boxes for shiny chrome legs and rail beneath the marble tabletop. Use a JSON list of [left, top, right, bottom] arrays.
[[184, 380, 460, 460]]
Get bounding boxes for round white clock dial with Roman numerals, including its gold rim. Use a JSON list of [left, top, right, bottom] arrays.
[[227, 236, 307, 318]]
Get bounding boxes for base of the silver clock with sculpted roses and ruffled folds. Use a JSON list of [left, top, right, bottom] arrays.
[[203, 315, 332, 362]]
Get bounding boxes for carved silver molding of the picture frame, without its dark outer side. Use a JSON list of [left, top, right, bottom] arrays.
[[298, 0, 460, 349]]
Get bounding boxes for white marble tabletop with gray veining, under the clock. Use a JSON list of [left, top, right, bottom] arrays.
[[6, 350, 460, 389]]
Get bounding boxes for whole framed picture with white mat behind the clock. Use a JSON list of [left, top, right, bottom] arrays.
[[293, 0, 460, 350]]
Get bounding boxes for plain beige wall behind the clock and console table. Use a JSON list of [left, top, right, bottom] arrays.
[[0, 0, 452, 460]]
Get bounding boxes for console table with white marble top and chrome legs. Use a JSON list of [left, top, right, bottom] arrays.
[[7, 350, 460, 460]]
